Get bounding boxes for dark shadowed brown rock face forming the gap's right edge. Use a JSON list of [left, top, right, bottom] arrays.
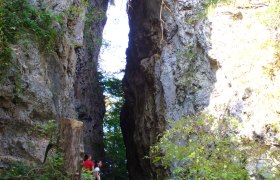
[[121, 0, 165, 179]]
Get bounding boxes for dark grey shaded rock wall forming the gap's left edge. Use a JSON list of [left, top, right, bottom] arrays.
[[74, 0, 108, 159]]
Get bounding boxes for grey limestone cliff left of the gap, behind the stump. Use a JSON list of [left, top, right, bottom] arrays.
[[0, 0, 108, 167]]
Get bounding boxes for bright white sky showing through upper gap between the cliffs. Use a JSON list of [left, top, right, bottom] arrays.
[[99, 0, 129, 76]]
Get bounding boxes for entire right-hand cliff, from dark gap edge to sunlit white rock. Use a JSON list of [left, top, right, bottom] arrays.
[[121, 0, 280, 179]]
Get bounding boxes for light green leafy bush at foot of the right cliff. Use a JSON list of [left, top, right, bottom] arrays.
[[150, 115, 248, 179]]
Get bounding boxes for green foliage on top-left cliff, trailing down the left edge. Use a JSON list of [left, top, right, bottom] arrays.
[[0, 0, 60, 79]]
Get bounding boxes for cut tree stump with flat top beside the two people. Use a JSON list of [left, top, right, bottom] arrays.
[[60, 118, 84, 179]]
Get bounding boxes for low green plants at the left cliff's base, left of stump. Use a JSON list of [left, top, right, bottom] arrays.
[[0, 150, 69, 180]]
